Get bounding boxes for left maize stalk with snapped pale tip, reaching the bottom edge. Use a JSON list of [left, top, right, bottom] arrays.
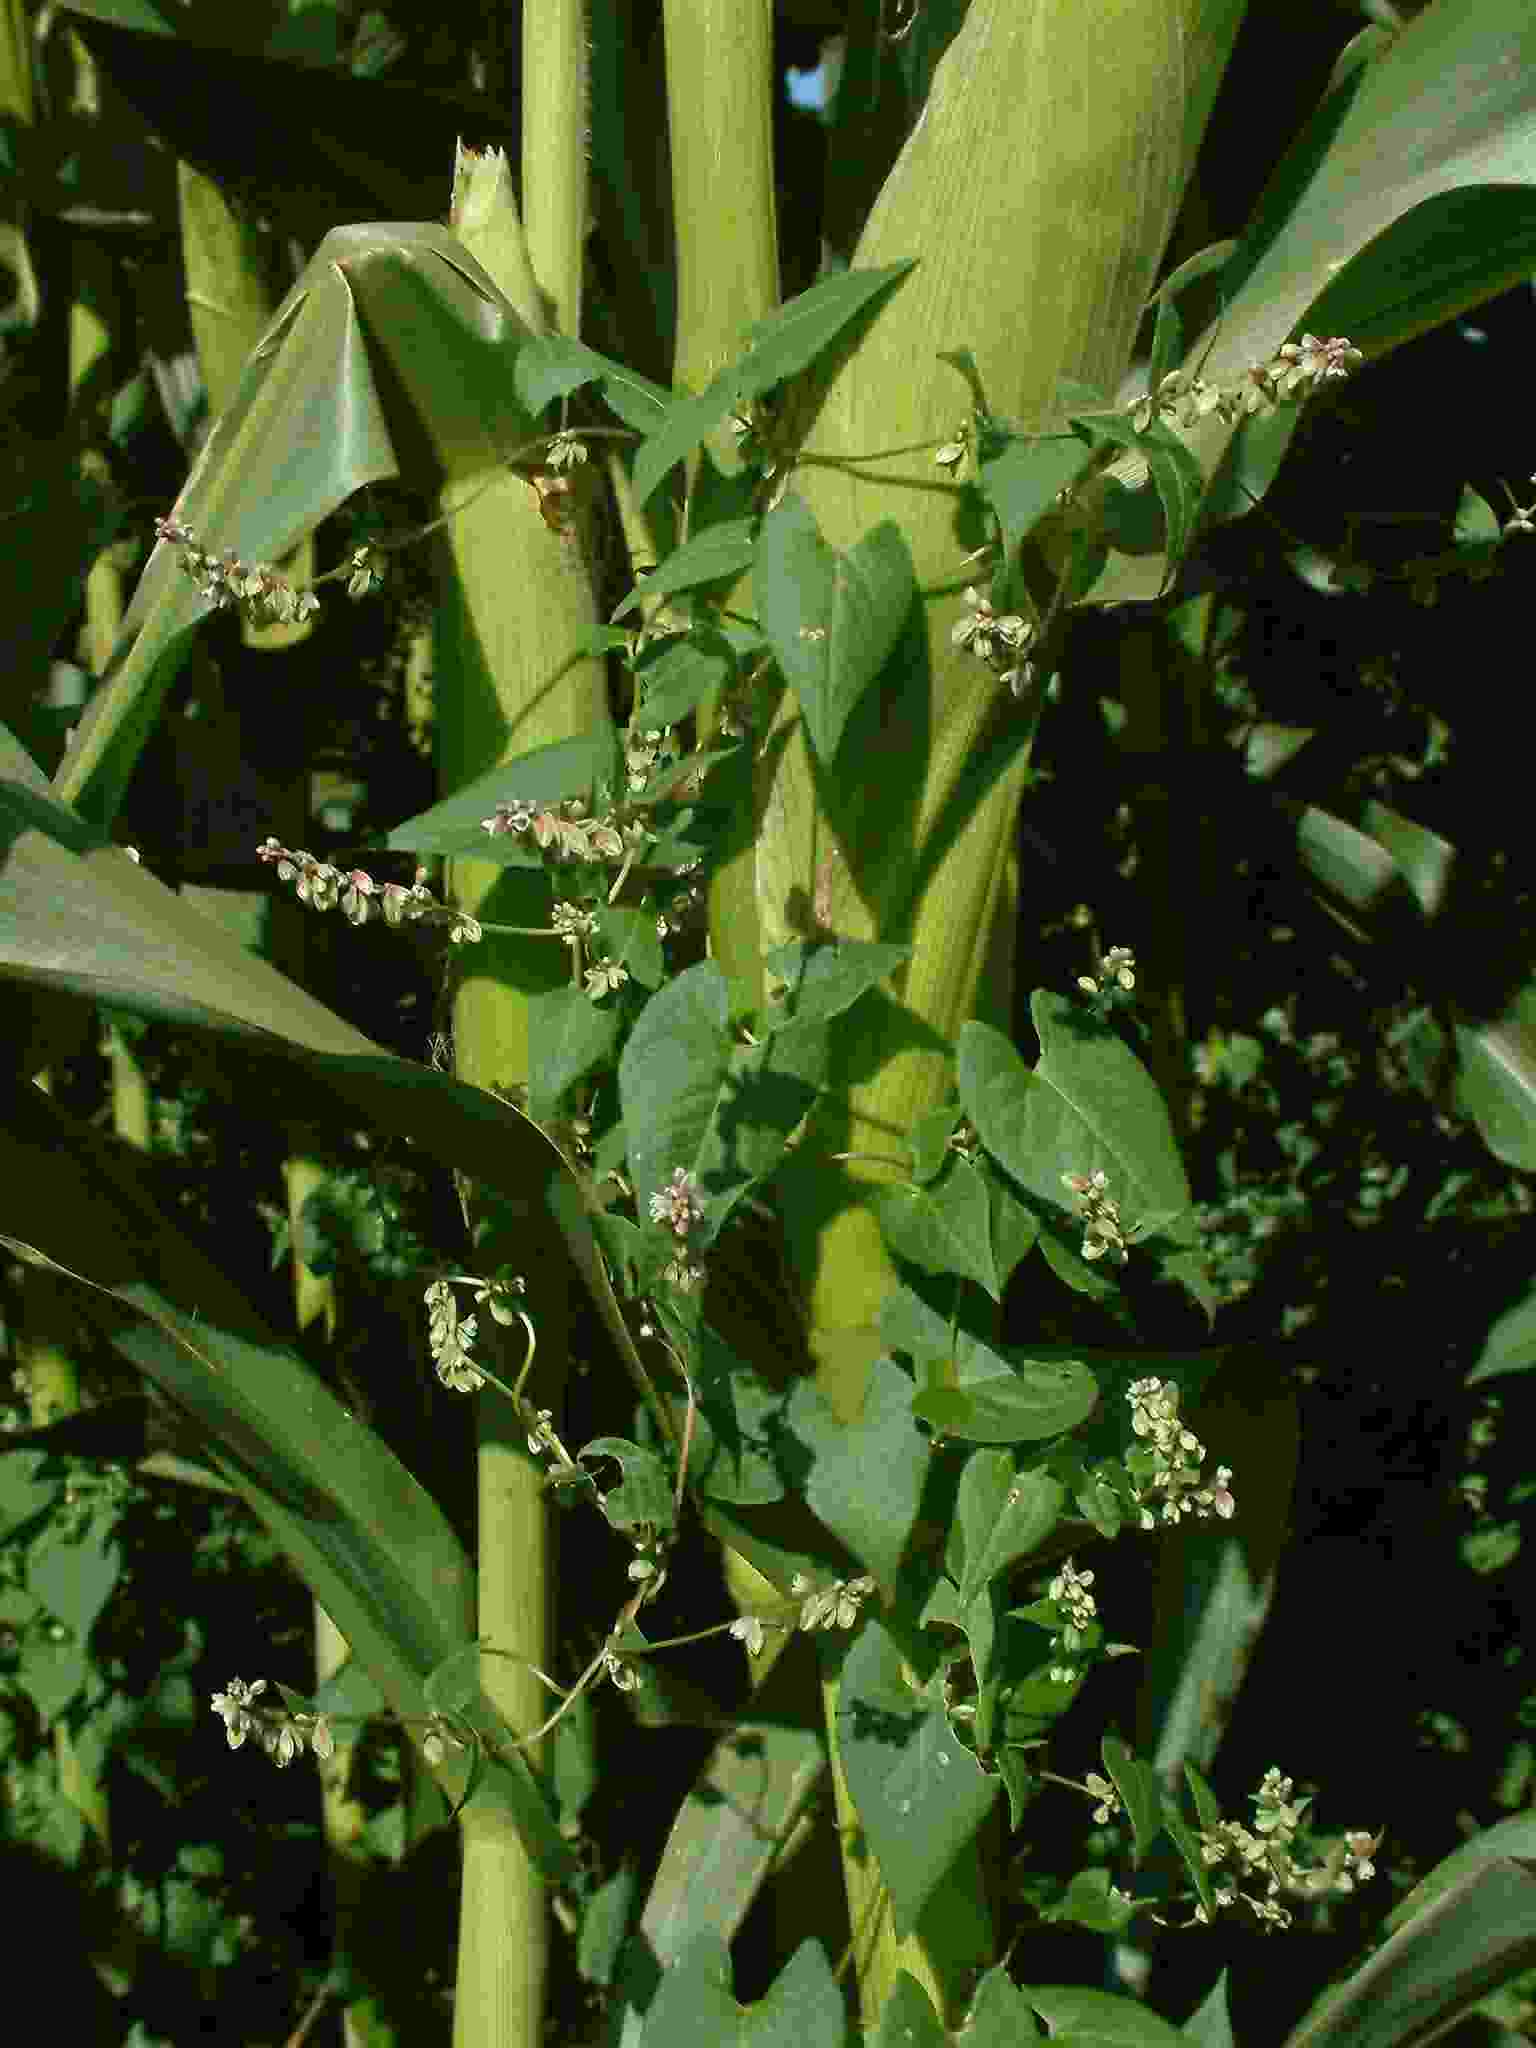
[[434, 119, 608, 2048]]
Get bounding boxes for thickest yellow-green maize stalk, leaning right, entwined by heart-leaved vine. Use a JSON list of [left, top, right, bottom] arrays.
[[758, 0, 1186, 2021]]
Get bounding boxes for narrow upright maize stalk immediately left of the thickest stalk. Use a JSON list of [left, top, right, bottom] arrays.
[[664, 0, 778, 1014]]
